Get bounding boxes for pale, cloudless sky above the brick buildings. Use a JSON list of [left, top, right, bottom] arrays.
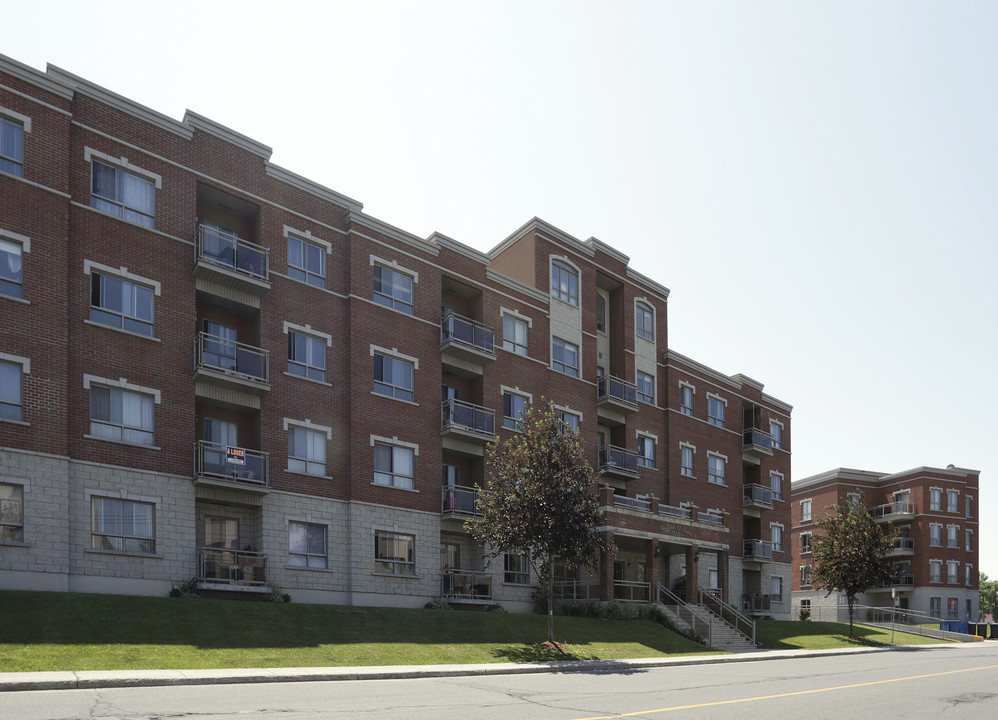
[[0, 0, 998, 577]]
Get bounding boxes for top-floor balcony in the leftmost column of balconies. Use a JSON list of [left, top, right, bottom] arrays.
[[194, 224, 270, 308]]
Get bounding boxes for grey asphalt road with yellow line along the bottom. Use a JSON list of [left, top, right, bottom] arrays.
[[0, 642, 998, 720]]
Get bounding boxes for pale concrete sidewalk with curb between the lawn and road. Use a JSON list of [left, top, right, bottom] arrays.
[[0, 645, 920, 692]]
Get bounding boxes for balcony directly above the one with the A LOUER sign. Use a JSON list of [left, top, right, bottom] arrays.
[[194, 332, 270, 409]]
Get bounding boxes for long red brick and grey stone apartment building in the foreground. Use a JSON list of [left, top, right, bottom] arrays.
[[0, 56, 791, 617]]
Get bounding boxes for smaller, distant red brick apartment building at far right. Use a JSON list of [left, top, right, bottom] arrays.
[[790, 465, 980, 621]]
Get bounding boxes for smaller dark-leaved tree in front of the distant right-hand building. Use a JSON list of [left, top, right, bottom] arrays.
[[811, 499, 894, 637]]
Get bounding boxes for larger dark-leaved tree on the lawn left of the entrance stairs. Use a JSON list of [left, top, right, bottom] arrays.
[[467, 399, 609, 644]]
